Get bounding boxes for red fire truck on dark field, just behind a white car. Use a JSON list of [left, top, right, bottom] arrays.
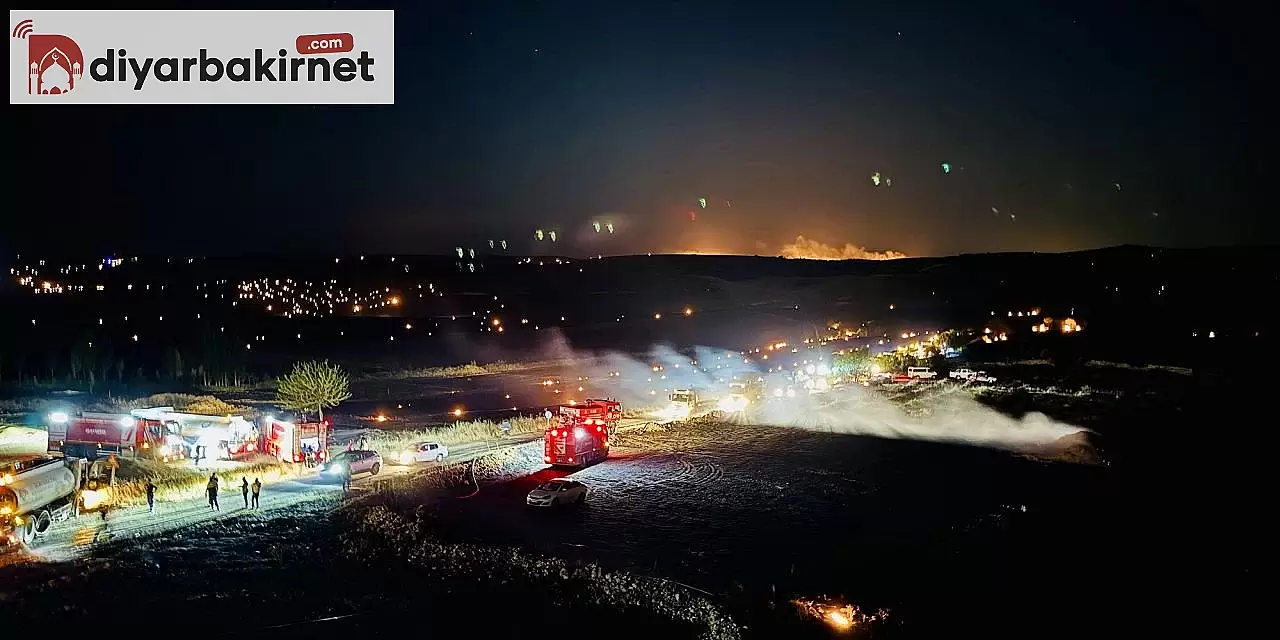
[[543, 399, 622, 467]]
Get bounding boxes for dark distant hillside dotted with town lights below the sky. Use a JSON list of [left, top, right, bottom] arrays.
[[0, 246, 1280, 389]]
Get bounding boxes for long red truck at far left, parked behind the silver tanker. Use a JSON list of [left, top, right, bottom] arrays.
[[47, 411, 187, 462]]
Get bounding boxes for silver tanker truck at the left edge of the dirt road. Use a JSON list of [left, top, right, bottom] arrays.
[[0, 456, 114, 548]]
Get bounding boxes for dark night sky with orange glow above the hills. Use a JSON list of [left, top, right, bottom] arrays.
[[10, 0, 1277, 255]]
